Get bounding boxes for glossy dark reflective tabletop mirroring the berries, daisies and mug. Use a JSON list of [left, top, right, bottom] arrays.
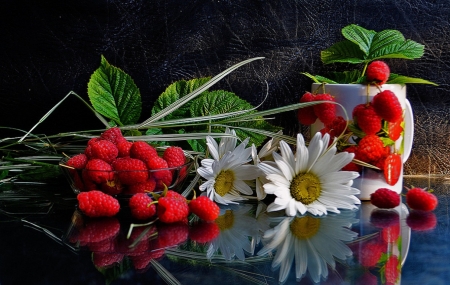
[[0, 178, 450, 284]]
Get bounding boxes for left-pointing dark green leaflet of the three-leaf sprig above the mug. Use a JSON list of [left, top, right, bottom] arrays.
[[320, 40, 365, 64]]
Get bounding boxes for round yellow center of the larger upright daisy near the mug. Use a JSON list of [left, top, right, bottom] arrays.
[[290, 173, 321, 205]]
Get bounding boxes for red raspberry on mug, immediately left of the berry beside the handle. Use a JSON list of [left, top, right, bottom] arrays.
[[353, 104, 381, 135]]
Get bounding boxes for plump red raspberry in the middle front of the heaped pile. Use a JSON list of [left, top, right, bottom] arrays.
[[112, 157, 148, 185]]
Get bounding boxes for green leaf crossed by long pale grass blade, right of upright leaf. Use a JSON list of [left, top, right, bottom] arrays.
[[152, 77, 211, 120]]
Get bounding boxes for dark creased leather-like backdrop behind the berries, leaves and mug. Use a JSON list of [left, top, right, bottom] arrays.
[[0, 0, 450, 174]]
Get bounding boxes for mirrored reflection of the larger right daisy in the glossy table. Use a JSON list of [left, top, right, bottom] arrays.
[[258, 211, 357, 282]]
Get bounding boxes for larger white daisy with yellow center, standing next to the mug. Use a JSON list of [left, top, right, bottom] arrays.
[[259, 133, 361, 216]]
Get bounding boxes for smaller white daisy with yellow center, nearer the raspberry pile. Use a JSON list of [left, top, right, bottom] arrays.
[[197, 128, 261, 205]]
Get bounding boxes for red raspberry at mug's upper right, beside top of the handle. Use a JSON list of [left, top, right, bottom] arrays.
[[372, 90, 403, 122]]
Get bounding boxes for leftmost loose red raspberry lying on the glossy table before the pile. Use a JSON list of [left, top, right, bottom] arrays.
[[77, 190, 120, 217]]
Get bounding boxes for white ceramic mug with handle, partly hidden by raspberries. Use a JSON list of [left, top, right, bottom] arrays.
[[311, 83, 414, 200]]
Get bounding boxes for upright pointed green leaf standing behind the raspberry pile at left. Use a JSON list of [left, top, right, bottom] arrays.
[[88, 56, 142, 126]]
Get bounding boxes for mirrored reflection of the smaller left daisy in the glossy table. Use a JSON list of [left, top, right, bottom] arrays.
[[207, 205, 258, 260]]
